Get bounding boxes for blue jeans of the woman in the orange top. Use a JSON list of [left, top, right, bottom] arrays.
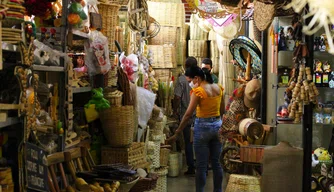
[[194, 117, 223, 192]]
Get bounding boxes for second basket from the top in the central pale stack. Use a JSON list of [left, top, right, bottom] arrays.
[[149, 25, 180, 46]]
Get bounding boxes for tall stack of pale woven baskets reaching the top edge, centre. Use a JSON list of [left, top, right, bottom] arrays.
[[147, 0, 186, 82]]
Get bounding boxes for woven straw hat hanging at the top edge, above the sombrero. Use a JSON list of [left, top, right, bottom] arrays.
[[254, 0, 294, 31]]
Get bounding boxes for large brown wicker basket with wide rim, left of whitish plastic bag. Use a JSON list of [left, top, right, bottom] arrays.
[[99, 105, 134, 147]]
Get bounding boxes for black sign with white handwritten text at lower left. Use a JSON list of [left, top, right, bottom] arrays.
[[25, 143, 49, 191]]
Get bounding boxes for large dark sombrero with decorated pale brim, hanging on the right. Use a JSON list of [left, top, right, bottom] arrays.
[[229, 36, 262, 74]]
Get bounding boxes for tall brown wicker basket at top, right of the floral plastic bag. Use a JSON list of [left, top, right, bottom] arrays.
[[97, 3, 120, 51]]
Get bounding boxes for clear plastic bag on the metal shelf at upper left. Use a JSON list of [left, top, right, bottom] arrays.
[[34, 40, 68, 66]]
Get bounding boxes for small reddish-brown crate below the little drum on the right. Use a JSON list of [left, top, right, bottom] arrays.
[[240, 145, 266, 163]]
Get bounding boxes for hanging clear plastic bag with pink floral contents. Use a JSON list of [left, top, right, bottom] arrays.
[[85, 30, 111, 76]]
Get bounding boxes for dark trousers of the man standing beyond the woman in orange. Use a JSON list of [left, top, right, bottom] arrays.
[[183, 125, 195, 171]]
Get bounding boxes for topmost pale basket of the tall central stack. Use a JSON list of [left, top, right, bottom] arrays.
[[147, 1, 185, 27]]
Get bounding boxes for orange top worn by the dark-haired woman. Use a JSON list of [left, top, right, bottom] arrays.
[[190, 85, 224, 118]]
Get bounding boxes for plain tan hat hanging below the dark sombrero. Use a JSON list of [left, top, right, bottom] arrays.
[[244, 79, 261, 108]]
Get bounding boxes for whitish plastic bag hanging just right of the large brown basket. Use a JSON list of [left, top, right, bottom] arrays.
[[137, 87, 156, 128]]
